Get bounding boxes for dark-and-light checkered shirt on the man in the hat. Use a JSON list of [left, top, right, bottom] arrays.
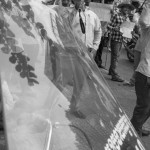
[[107, 13, 126, 42]]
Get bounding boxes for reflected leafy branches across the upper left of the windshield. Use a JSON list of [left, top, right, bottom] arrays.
[[0, 0, 38, 85]]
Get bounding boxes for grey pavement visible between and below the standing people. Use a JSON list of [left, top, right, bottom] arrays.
[[101, 49, 150, 150]]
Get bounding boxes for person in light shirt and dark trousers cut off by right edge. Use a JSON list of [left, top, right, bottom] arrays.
[[131, 3, 150, 136]]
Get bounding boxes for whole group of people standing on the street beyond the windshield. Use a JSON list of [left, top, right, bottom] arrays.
[[42, 0, 150, 137]]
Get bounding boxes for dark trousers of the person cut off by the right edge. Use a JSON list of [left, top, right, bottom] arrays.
[[131, 72, 150, 134]]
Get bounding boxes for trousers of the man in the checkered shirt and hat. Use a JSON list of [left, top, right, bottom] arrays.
[[109, 39, 122, 76]]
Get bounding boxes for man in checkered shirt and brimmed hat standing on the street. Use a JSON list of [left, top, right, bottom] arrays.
[[107, 3, 134, 82]]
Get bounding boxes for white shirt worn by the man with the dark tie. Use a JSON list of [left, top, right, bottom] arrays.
[[72, 8, 102, 50]]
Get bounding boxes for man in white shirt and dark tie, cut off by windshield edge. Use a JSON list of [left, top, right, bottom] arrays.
[[72, 0, 102, 57]]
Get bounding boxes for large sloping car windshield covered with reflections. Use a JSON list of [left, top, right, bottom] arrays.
[[0, 0, 144, 150]]
